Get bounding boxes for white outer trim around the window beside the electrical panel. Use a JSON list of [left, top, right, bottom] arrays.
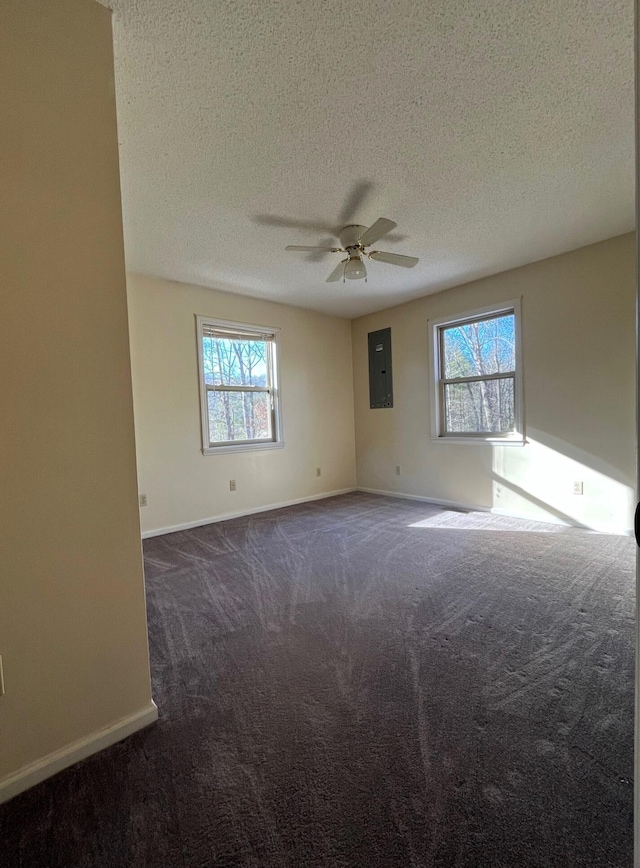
[[429, 298, 526, 446]]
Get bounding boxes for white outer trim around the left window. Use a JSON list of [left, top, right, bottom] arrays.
[[196, 315, 284, 455]]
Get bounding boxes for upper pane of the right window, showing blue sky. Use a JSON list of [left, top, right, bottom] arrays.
[[442, 313, 516, 380]]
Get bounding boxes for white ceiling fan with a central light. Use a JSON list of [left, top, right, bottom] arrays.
[[285, 217, 418, 283]]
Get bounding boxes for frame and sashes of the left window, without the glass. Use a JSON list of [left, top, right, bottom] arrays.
[[196, 315, 284, 455]]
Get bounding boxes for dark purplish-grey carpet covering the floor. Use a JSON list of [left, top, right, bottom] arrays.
[[0, 494, 635, 868]]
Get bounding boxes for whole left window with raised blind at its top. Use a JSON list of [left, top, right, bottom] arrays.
[[196, 317, 282, 453]]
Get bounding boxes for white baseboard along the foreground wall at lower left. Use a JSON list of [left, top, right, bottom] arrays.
[[0, 700, 158, 804]]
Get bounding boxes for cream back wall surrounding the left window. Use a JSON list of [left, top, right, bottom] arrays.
[[128, 274, 355, 532]]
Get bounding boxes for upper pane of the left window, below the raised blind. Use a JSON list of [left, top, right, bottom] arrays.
[[202, 337, 268, 386]]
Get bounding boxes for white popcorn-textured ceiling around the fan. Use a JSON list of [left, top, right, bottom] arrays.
[[105, 0, 634, 317]]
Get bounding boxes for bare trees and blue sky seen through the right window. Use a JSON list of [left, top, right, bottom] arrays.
[[438, 312, 516, 435]]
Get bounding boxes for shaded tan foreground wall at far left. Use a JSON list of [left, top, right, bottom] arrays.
[[0, 0, 151, 799]]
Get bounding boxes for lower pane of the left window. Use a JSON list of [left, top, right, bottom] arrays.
[[207, 392, 272, 443]]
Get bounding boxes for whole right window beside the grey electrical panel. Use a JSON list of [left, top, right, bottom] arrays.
[[431, 302, 523, 443]]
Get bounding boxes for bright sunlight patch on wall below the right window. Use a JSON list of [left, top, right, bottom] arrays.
[[491, 438, 635, 533]]
